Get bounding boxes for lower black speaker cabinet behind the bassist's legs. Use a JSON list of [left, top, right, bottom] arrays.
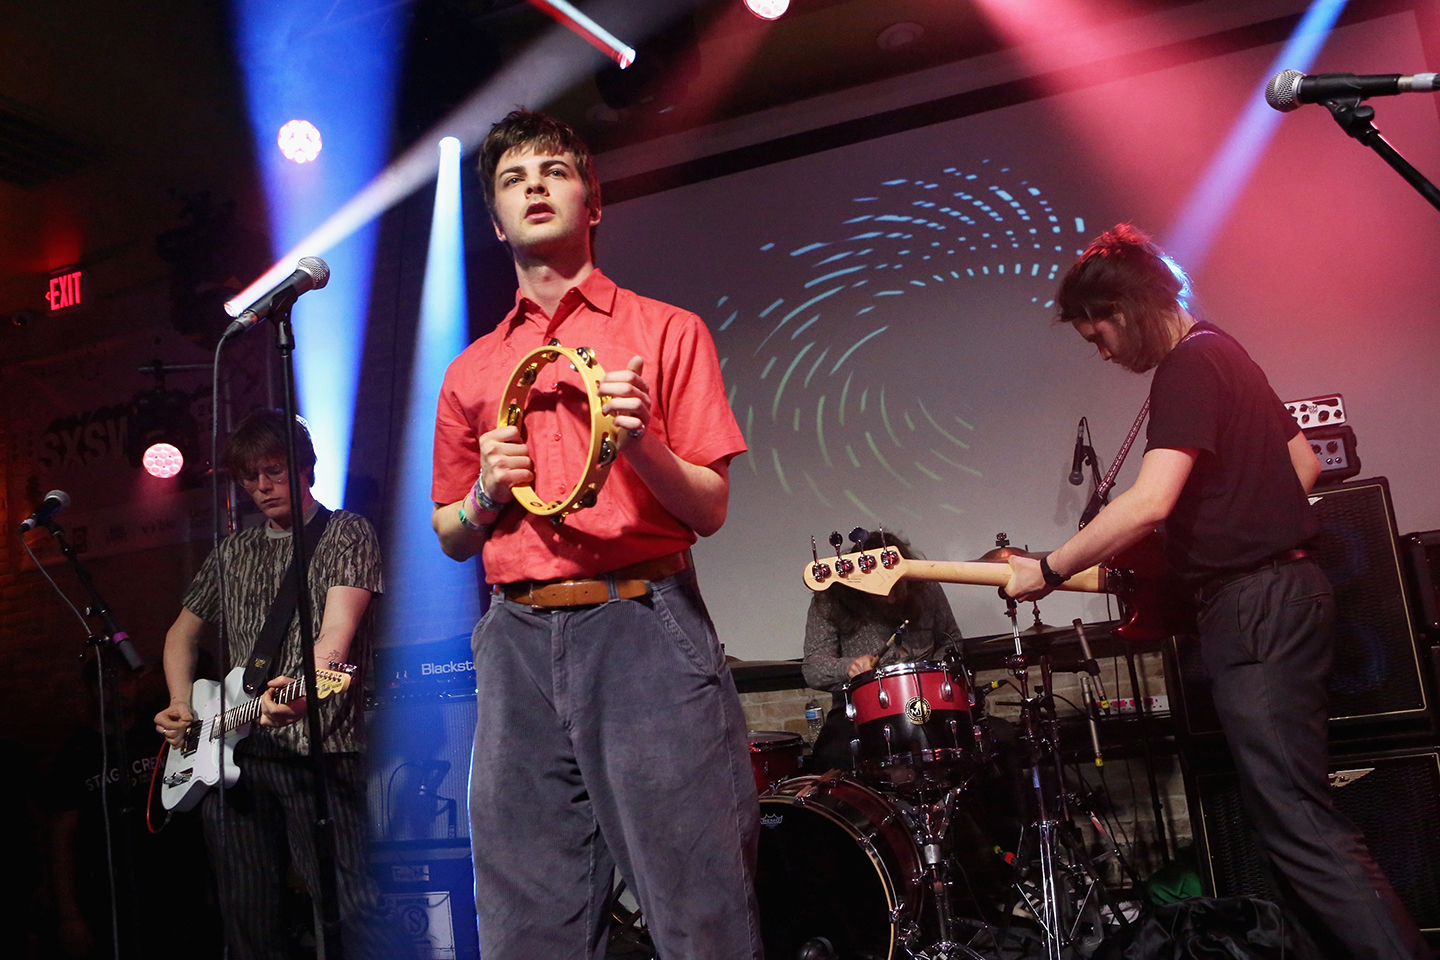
[[1192, 748, 1440, 931]]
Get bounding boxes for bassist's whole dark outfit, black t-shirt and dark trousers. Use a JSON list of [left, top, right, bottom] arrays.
[[1146, 324, 1430, 960]]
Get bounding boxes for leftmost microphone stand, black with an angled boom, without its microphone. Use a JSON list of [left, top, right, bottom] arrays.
[[42, 520, 145, 959]]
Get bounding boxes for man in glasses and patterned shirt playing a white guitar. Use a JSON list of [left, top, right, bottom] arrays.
[[156, 410, 415, 960]]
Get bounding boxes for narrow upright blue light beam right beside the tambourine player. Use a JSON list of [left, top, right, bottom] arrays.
[[382, 137, 480, 643]]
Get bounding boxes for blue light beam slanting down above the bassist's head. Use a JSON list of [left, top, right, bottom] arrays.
[[1165, 0, 1345, 273]]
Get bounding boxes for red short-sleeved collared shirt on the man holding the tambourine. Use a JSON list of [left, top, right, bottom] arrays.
[[431, 271, 746, 583]]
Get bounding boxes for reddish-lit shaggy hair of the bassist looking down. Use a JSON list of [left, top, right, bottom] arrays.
[[1056, 223, 1184, 373]]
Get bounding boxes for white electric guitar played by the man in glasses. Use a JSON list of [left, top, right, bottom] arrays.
[[160, 662, 356, 810]]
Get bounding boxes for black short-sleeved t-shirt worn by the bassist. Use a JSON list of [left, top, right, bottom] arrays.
[[1145, 322, 1319, 581]]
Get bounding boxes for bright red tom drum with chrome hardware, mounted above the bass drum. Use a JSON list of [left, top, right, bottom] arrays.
[[845, 661, 978, 789]]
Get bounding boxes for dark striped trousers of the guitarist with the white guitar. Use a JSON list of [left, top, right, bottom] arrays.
[[202, 741, 415, 960]]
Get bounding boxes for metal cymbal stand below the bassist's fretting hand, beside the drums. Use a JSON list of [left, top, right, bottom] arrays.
[[1005, 597, 1123, 960]]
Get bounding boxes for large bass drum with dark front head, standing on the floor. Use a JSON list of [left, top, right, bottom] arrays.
[[755, 774, 924, 960]]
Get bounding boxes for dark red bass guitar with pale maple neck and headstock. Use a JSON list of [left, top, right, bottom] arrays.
[[804, 534, 1195, 642]]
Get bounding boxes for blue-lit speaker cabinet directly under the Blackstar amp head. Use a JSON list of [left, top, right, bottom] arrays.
[[366, 687, 475, 841]]
